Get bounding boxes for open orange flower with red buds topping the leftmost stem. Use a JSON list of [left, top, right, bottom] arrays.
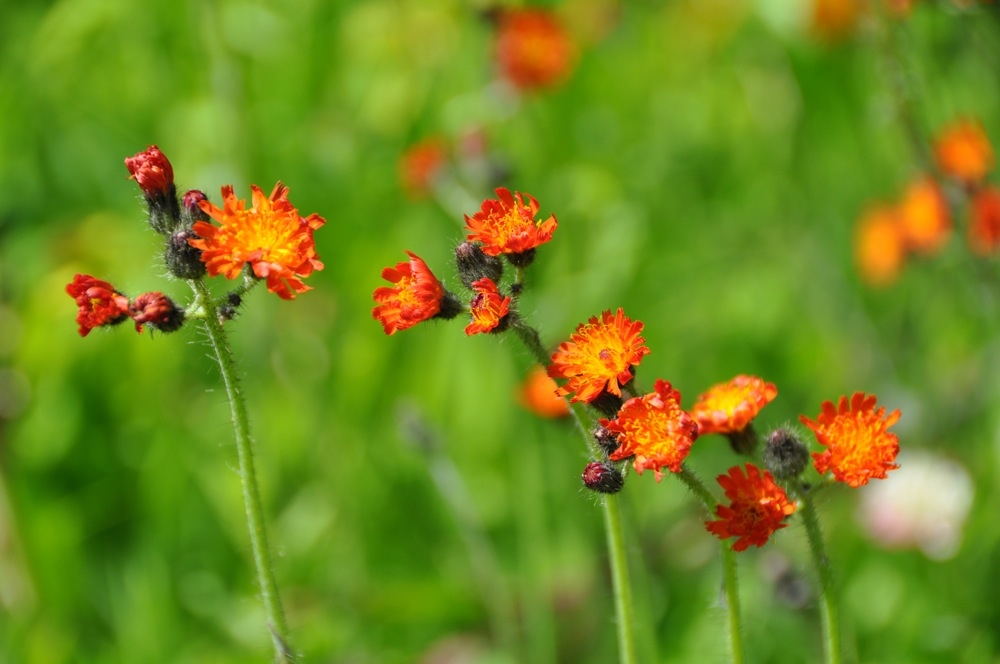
[[66, 145, 325, 336]]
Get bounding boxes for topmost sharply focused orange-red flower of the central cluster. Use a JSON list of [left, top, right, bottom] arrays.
[[465, 187, 557, 256]]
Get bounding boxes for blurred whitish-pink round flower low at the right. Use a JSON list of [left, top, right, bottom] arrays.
[[858, 451, 973, 560]]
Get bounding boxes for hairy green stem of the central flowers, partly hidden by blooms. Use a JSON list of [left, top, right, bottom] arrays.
[[512, 317, 636, 664]]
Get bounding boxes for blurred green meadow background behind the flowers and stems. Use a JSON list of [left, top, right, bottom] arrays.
[[0, 0, 1000, 664]]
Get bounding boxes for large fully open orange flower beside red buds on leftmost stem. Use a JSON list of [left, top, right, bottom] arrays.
[[189, 182, 326, 300]]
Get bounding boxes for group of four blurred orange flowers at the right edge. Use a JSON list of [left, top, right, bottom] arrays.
[[855, 119, 1000, 286]]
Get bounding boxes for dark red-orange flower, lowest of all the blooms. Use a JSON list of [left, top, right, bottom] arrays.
[[705, 463, 795, 551]]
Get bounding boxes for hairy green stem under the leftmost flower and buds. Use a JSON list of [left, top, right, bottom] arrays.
[[189, 280, 292, 664]]
